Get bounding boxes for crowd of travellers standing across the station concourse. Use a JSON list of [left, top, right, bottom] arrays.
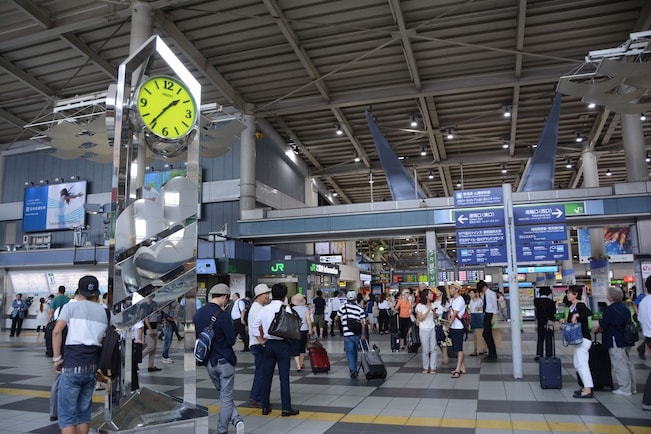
[[37, 276, 651, 434]]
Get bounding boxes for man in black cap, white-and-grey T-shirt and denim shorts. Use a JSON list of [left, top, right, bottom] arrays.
[[52, 276, 108, 434]]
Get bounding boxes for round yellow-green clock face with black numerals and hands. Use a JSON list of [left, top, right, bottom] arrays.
[[136, 76, 197, 140]]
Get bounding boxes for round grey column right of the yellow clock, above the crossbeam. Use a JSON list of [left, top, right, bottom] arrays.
[[240, 104, 256, 217]]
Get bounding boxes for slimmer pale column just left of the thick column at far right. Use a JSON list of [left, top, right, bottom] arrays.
[[581, 149, 610, 309]]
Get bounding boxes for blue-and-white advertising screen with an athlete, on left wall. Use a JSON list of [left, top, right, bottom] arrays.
[[23, 181, 86, 232]]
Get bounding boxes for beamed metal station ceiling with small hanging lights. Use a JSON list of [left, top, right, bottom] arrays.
[[0, 0, 651, 270]]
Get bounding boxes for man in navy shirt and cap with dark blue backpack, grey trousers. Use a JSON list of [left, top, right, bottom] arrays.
[[194, 283, 244, 434]]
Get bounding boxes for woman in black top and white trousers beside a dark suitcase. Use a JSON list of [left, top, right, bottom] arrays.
[[566, 285, 594, 398]]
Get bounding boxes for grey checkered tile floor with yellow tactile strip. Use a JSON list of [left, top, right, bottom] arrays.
[[0, 323, 651, 434]]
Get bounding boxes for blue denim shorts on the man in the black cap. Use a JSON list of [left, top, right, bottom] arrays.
[[57, 369, 95, 429]]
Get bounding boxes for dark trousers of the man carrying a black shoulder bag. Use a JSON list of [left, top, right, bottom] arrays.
[[262, 339, 292, 411]]
